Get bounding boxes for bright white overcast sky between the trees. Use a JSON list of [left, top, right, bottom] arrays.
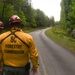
[[31, 0, 61, 21]]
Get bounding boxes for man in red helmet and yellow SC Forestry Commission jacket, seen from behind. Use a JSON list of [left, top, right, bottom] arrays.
[[0, 15, 38, 75]]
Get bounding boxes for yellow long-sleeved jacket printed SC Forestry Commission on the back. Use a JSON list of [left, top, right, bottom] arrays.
[[0, 28, 38, 68]]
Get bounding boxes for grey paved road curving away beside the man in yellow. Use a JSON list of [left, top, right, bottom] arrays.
[[30, 29, 75, 75]]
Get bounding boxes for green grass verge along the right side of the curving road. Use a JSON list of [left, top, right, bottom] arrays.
[[45, 28, 75, 52]]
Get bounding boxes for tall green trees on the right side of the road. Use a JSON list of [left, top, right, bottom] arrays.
[[60, 0, 75, 38]]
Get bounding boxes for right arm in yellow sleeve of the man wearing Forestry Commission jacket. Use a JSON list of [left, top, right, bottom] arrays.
[[30, 38, 38, 74]]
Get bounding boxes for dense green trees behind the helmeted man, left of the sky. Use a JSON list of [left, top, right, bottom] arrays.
[[0, 0, 55, 28]]
